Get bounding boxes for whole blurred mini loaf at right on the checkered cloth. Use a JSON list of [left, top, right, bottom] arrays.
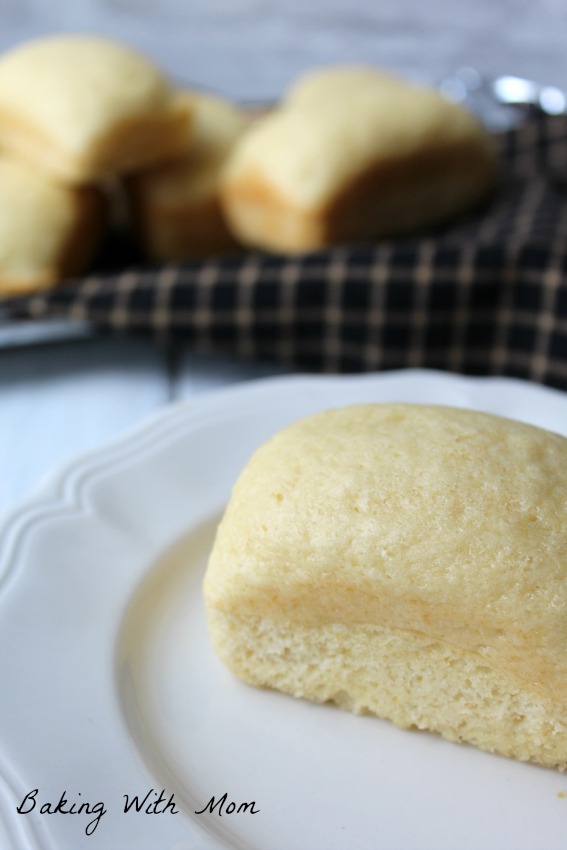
[[223, 67, 495, 252]]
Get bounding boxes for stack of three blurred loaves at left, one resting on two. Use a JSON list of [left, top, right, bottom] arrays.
[[0, 36, 248, 295]]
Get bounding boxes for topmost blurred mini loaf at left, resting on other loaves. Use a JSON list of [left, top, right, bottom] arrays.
[[0, 36, 190, 183]]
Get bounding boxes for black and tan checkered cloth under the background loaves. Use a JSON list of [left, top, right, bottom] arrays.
[[5, 103, 567, 389]]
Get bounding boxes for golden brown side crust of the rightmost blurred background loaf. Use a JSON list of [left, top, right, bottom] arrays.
[[222, 133, 495, 252]]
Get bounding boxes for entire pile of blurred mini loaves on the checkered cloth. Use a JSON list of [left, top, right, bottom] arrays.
[[0, 36, 494, 295]]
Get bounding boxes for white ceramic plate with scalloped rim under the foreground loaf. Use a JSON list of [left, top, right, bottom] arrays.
[[0, 371, 567, 850]]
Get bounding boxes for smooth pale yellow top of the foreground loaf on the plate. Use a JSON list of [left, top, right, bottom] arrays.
[[204, 404, 567, 705]]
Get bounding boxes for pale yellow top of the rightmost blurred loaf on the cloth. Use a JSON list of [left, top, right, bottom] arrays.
[[225, 67, 489, 210]]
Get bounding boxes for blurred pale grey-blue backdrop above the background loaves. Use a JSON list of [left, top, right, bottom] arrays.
[[0, 0, 567, 97]]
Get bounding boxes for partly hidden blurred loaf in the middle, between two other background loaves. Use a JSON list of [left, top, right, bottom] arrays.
[[127, 92, 250, 262]]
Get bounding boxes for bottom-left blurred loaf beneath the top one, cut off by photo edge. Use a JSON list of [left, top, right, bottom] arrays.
[[0, 156, 105, 295]]
